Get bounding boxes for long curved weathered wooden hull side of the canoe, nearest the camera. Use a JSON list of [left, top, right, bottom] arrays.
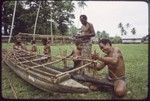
[[4, 56, 90, 93]]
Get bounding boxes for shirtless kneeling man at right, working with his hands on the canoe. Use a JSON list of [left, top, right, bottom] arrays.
[[92, 39, 126, 97]]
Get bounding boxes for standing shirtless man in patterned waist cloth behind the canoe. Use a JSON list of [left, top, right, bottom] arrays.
[[76, 15, 95, 75]]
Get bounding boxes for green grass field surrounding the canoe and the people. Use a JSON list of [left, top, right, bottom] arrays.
[[1, 44, 148, 99]]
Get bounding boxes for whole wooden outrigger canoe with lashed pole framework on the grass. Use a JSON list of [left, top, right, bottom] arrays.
[[2, 47, 113, 93]]
